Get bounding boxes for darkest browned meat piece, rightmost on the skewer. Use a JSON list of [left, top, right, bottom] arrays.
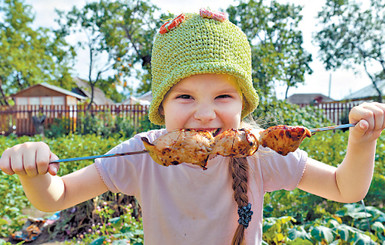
[[260, 125, 311, 156]]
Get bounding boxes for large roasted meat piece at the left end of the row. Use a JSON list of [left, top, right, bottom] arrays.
[[142, 129, 214, 169]]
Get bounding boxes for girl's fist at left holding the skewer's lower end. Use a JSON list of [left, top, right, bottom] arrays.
[[0, 142, 59, 177]]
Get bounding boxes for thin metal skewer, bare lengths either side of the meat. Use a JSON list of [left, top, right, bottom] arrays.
[[50, 124, 355, 163]]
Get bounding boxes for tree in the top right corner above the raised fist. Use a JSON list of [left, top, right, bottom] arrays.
[[315, 0, 385, 102]]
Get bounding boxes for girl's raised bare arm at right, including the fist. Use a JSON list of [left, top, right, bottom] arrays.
[[298, 103, 385, 203]]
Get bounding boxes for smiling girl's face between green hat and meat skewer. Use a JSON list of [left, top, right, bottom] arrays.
[[160, 74, 242, 131]]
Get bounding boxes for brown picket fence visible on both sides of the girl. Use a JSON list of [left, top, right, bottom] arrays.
[[0, 101, 360, 136]]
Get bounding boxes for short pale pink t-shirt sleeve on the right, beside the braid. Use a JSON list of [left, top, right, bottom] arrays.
[[260, 146, 308, 192]]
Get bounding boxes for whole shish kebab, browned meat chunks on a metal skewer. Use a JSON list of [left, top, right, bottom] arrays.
[[50, 124, 355, 169]]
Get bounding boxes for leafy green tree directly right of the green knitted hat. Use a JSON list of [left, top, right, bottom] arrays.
[[227, 0, 312, 98]]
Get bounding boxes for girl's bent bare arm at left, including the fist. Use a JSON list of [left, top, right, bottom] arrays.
[[0, 142, 107, 212]]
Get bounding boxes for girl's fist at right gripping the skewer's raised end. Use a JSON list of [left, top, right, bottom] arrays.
[[349, 102, 385, 143]]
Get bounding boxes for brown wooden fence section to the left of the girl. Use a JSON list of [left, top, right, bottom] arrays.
[[0, 105, 148, 136]]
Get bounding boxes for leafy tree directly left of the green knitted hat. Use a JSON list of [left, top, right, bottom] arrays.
[[97, 0, 171, 92]]
